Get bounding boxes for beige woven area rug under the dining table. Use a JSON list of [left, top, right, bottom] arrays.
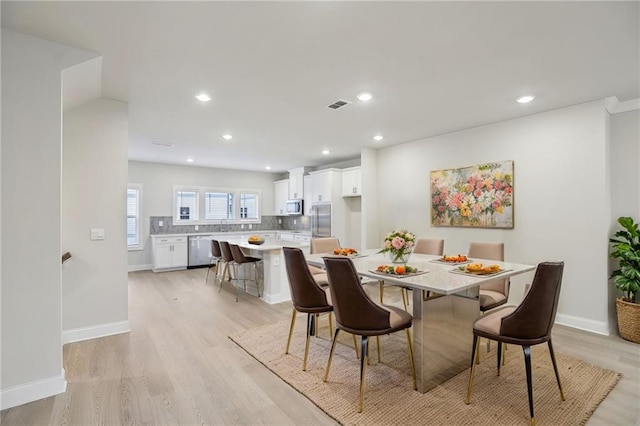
[[230, 315, 620, 425]]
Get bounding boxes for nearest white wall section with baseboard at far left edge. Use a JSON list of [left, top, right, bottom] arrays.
[[0, 29, 97, 409]]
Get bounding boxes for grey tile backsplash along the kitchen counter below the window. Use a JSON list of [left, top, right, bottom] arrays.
[[149, 216, 311, 235]]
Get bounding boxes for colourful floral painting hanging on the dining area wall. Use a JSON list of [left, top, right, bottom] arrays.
[[431, 161, 513, 228]]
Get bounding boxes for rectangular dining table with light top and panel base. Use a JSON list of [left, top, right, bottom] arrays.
[[306, 249, 536, 393]]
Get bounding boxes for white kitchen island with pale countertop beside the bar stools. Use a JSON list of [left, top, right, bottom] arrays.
[[220, 238, 309, 304]]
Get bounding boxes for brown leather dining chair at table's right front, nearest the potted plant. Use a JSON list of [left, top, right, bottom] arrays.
[[464, 262, 565, 426]]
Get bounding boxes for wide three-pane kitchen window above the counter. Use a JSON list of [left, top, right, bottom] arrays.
[[173, 185, 262, 225]]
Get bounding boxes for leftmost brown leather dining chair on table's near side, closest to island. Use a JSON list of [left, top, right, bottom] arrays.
[[282, 247, 333, 371]]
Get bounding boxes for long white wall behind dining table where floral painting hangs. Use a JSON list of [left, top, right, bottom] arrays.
[[377, 101, 610, 334]]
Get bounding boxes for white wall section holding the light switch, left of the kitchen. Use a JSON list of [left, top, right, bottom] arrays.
[[61, 99, 129, 343]]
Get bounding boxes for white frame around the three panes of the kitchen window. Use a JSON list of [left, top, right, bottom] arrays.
[[172, 185, 262, 225]]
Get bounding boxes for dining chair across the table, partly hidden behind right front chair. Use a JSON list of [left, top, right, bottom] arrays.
[[467, 241, 510, 352]]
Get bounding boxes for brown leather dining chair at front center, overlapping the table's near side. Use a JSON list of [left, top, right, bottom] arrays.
[[323, 257, 417, 413]]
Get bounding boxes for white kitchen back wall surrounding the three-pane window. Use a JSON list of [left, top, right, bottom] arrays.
[[128, 161, 277, 269]]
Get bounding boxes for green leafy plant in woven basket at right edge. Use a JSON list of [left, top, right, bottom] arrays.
[[609, 216, 640, 343]]
